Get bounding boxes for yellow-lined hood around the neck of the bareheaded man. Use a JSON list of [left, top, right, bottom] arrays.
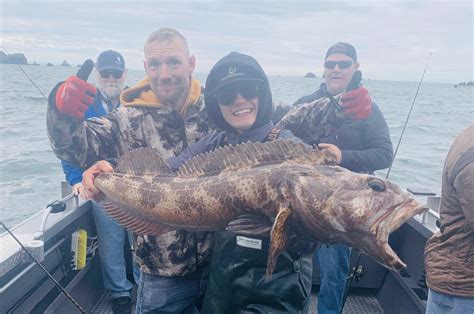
[[120, 77, 201, 115]]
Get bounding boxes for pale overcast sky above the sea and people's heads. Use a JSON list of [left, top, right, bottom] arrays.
[[0, 0, 474, 83]]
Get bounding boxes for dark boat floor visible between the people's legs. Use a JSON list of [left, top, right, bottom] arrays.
[[90, 289, 384, 314]]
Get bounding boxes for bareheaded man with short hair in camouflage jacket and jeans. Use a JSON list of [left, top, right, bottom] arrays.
[[47, 28, 212, 312]]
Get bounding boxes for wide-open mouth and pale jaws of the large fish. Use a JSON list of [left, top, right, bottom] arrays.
[[369, 198, 428, 270]]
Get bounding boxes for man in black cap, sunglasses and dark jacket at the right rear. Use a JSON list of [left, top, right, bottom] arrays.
[[277, 42, 393, 313]]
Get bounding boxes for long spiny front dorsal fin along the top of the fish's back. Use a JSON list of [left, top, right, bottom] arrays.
[[178, 140, 336, 177]]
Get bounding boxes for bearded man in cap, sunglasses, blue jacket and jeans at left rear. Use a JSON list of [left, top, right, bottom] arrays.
[[61, 50, 139, 313]]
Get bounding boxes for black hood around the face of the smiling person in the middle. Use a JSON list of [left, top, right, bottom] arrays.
[[204, 52, 273, 133]]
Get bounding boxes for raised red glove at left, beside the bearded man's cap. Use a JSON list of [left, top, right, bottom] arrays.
[[56, 76, 97, 119]]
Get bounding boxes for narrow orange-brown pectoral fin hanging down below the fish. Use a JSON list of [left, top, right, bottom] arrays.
[[267, 207, 291, 278]]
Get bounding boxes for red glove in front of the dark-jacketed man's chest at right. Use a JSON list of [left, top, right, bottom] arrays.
[[339, 87, 372, 120]]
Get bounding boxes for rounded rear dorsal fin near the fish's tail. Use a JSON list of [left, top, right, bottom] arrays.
[[115, 148, 174, 175]]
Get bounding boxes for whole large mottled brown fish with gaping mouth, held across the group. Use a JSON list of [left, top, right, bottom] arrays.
[[95, 140, 425, 276]]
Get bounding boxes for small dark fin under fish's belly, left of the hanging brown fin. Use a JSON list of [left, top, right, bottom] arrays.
[[226, 214, 272, 237]]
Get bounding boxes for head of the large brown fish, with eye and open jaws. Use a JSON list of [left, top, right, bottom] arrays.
[[296, 166, 427, 270]]
